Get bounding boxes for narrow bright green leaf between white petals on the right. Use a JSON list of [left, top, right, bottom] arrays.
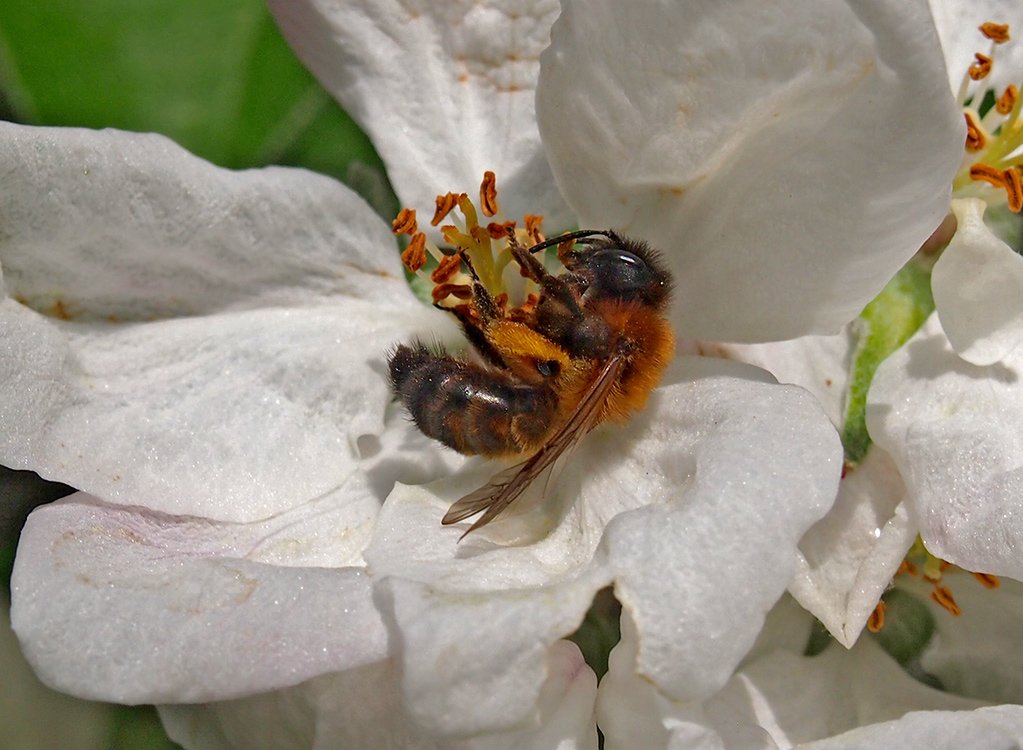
[[842, 262, 934, 464]]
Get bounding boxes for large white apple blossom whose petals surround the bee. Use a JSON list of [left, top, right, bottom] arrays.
[[0, 0, 963, 747]]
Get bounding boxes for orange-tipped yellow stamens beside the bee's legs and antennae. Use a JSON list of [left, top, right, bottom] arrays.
[[391, 171, 544, 318]]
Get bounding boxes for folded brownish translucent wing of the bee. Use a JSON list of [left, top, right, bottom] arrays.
[[441, 357, 625, 538]]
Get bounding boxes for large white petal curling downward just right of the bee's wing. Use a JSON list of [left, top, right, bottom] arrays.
[[607, 359, 842, 698]]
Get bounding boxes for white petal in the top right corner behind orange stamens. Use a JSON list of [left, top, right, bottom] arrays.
[[930, 0, 1023, 94]]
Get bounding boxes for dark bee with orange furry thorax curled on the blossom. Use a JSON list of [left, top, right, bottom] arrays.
[[389, 230, 674, 536]]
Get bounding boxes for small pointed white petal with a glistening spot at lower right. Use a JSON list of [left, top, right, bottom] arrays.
[[789, 446, 917, 648]]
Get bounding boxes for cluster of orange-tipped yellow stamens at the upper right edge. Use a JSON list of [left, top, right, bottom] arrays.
[[952, 23, 1023, 213]]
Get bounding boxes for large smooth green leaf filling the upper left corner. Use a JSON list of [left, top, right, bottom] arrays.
[[0, 0, 382, 179]]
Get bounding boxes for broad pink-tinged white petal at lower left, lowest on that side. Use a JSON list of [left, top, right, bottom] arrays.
[[11, 489, 387, 703]]
